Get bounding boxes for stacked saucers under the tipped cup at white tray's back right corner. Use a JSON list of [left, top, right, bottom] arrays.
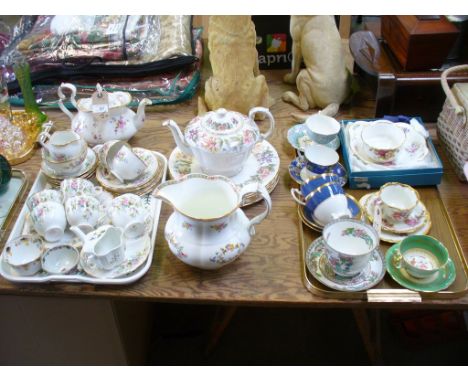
[[96, 147, 164, 196]]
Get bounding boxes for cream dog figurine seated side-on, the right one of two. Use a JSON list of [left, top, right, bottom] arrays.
[[282, 16, 351, 122]]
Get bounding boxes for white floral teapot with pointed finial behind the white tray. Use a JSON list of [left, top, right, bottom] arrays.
[[58, 83, 151, 146]]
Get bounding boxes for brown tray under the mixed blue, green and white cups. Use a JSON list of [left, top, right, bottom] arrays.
[[298, 187, 468, 302]]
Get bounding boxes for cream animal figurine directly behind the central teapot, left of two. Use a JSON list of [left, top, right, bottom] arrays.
[[198, 16, 273, 117]]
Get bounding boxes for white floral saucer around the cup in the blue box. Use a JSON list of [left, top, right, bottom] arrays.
[[348, 121, 429, 169]]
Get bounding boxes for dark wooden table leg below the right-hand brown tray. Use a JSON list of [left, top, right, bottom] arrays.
[[353, 308, 382, 365]]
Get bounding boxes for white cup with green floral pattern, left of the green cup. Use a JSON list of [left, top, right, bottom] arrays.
[[323, 219, 379, 277]]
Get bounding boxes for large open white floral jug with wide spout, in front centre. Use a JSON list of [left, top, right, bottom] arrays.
[[153, 174, 271, 269]]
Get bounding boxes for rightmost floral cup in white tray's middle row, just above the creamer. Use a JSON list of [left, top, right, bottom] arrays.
[[109, 194, 149, 239]]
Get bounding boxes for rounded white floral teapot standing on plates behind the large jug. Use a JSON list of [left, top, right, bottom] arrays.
[[163, 107, 275, 177]]
